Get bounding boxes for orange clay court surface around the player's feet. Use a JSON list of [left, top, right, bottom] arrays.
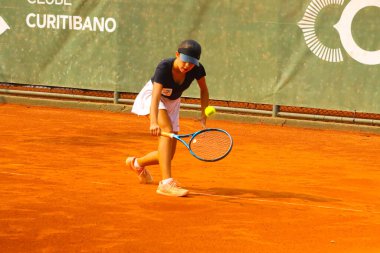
[[0, 104, 380, 253]]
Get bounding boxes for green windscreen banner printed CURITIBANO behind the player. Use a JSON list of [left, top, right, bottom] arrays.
[[0, 0, 380, 113]]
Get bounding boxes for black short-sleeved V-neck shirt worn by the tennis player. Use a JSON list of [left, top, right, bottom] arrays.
[[151, 58, 206, 100]]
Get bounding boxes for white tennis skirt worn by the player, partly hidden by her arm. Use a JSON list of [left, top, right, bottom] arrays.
[[132, 80, 181, 132]]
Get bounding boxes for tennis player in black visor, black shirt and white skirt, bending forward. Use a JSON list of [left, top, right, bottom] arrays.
[[126, 40, 209, 197]]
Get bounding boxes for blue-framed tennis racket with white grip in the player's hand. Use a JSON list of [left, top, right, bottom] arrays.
[[161, 128, 233, 162]]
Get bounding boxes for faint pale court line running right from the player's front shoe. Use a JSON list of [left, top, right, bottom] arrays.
[[190, 191, 380, 214]]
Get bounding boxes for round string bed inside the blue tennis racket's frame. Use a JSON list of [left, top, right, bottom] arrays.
[[190, 131, 232, 161]]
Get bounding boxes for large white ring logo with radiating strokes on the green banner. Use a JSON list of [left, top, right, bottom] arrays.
[[298, 0, 380, 65]]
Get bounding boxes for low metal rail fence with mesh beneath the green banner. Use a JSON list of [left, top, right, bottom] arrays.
[[0, 83, 380, 126]]
